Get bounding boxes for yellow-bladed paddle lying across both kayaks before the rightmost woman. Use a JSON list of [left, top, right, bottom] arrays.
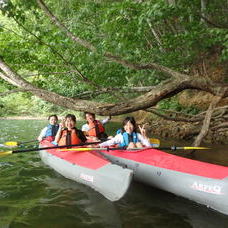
[[58, 146, 211, 151]]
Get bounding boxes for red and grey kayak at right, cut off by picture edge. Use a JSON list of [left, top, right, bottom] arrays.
[[101, 148, 228, 215]]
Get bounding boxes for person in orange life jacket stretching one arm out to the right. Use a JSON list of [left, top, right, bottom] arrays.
[[82, 112, 111, 141]]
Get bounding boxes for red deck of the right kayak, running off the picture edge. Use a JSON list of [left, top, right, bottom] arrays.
[[102, 148, 228, 179]]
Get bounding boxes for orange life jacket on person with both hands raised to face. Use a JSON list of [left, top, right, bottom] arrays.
[[58, 128, 82, 146]]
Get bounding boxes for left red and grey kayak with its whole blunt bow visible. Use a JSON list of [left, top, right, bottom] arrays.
[[39, 141, 133, 201]]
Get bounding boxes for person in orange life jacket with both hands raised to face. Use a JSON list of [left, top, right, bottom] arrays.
[[52, 114, 87, 146]]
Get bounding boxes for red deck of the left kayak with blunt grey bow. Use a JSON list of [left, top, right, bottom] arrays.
[[41, 141, 110, 170]]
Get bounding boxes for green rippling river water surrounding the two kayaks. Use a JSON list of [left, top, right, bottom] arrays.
[[0, 120, 228, 228]]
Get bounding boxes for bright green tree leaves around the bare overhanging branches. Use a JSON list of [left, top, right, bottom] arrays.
[[0, 0, 228, 116]]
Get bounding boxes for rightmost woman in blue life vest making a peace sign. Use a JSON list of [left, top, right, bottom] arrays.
[[99, 117, 151, 149]]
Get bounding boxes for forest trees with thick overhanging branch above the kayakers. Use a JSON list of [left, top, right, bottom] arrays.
[[0, 0, 228, 144]]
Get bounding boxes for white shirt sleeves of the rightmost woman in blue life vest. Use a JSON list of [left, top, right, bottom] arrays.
[[99, 133, 151, 147]]
